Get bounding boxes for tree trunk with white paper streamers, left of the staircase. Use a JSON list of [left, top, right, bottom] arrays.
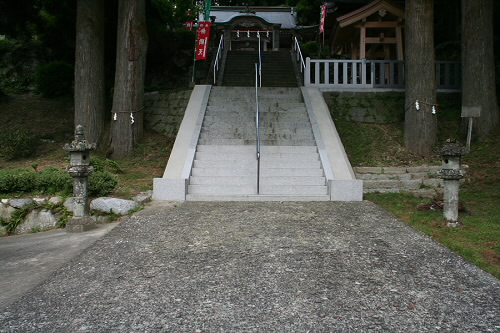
[[111, 0, 148, 158]]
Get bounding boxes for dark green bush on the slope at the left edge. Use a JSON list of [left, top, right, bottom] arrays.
[[0, 128, 37, 159]]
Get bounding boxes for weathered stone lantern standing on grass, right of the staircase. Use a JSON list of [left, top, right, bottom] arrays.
[[436, 140, 469, 227]]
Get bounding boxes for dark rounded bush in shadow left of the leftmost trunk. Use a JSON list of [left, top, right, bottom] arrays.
[[36, 61, 74, 97]]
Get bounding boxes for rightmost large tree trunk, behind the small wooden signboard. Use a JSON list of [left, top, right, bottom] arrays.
[[462, 0, 499, 140]]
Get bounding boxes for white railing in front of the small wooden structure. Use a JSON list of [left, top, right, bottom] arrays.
[[304, 58, 460, 91]]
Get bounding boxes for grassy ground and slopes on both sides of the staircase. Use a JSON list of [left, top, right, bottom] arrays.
[[0, 95, 500, 278]]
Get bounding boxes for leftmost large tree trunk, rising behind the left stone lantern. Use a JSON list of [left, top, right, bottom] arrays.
[[75, 0, 106, 143]]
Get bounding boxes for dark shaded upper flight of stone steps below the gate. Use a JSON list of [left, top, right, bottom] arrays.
[[222, 50, 297, 87]]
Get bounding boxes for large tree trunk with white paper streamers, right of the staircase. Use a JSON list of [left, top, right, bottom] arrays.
[[404, 0, 437, 156]]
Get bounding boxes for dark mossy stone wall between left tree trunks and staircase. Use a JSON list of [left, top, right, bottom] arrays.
[[144, 89, 192, 137]]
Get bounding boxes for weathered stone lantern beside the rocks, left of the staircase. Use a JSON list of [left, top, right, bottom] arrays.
[[64, 125, 96, 232]]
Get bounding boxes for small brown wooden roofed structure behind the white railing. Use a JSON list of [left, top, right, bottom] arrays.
[[332, 0, 405, 61]]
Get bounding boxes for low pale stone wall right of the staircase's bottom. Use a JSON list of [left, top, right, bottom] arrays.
[[354, 166, 443, 198]]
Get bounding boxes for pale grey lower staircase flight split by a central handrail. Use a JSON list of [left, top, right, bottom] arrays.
[[186, 87, 330, 201]]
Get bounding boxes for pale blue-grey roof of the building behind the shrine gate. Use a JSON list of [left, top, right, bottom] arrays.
[[206, 6, 297, 29]]
